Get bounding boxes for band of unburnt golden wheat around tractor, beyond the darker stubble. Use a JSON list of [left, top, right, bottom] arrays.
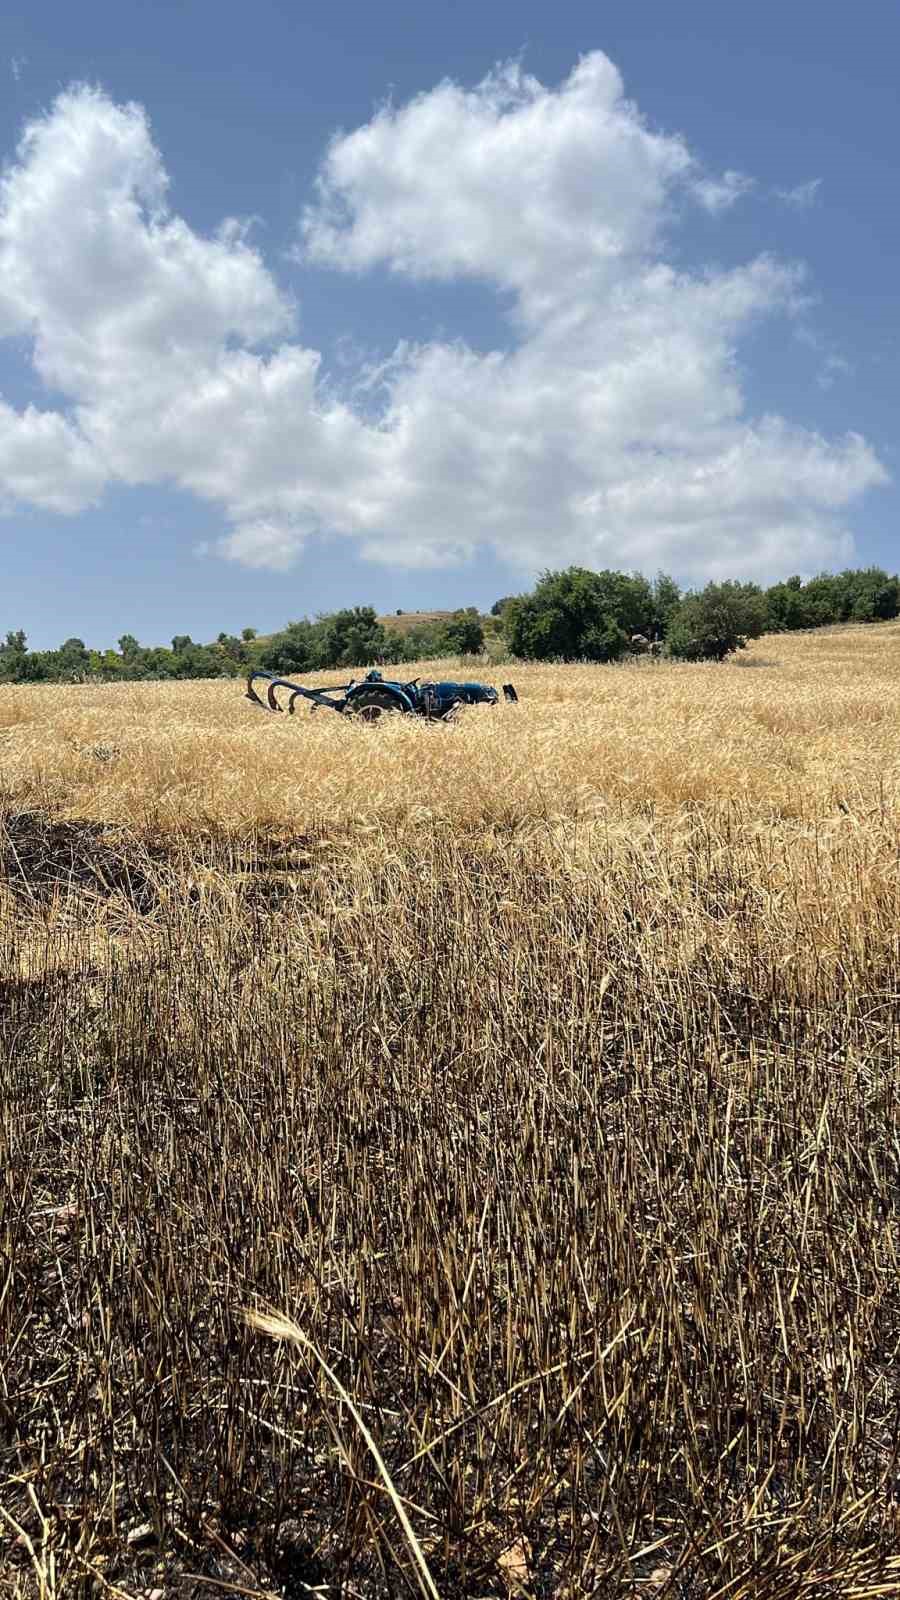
[[0, 624, 900, 832]]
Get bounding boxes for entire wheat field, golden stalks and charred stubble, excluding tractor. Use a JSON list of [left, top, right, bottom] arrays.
[[0, 624, 900, 1600]]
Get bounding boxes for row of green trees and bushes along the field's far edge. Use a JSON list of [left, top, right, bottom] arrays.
[[0, 566, 900, 683]]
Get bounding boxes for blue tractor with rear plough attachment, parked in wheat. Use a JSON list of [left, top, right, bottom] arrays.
[[247, 672, 519, 722]]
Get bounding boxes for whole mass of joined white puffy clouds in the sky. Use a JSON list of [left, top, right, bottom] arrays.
[[0, 67, 884, 588]]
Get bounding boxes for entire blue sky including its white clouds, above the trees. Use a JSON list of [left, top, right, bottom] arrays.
[[0, 0, 900, 646]]
